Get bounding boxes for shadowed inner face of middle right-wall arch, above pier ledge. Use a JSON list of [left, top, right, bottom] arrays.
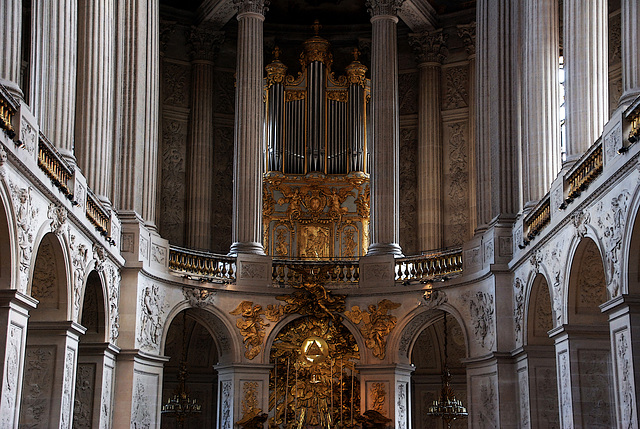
[[565, 237, 607, 324]]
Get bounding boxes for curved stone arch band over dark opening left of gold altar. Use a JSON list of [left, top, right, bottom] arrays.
[[160, 301, 239, 363]]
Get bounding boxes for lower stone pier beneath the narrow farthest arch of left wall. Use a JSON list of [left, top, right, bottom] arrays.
[[73, 342, 120, 428]]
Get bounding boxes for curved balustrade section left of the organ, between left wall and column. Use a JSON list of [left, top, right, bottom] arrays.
[[169, 246, 236, 283]]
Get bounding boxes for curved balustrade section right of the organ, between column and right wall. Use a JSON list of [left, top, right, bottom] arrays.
[[395, 248, 462, 283]]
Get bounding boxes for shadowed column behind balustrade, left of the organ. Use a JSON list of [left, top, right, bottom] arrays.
[[187, 27, 224, 250]]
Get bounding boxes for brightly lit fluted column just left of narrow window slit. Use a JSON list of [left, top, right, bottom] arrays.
[[522, 0, 560, 207]]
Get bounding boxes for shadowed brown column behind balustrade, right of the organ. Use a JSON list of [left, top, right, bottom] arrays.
[[409, 29, 447, 250]]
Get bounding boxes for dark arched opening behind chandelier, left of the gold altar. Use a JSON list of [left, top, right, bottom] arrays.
[[161, 309, 220, 429]]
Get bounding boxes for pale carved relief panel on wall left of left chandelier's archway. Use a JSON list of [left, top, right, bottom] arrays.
[[138, 284, 168, 351]]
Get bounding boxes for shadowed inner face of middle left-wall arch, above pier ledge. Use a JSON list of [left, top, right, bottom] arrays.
[[27, 232, 72, 321]]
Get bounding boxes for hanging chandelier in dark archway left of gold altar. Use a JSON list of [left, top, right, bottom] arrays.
[[162, 311, 202, 428]]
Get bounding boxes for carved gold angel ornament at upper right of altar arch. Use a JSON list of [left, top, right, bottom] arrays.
[[344, 299, 400, 360]]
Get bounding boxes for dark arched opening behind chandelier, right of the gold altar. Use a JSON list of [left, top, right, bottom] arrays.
[[411, 313, 468, 429]]
